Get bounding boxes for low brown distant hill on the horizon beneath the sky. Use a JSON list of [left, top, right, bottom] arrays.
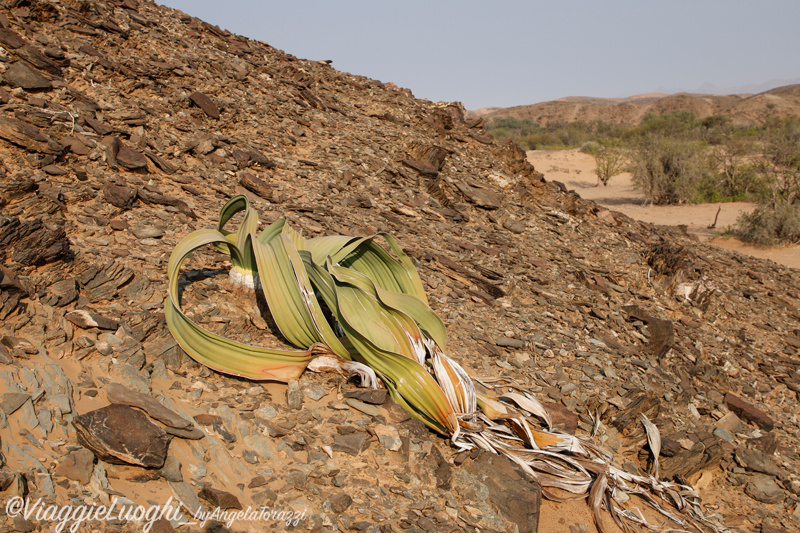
[[475, 84, 800, 125]]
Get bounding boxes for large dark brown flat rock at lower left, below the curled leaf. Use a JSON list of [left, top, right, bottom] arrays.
[[73, 404, 169, 468]]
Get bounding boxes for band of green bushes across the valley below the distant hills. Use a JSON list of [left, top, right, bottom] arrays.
[[488, 111, 800, 233]]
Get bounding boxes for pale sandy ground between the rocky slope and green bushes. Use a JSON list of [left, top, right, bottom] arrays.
[[528, 150, 800, 268]]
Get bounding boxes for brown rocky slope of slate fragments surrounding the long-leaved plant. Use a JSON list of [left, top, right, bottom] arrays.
[[0, 0, 800, 532]]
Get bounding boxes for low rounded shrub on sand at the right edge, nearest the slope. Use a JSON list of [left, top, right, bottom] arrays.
[[734, 198, 800, 244]]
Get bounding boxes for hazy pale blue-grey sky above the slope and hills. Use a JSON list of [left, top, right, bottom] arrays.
[[161, 0, 800, 109]]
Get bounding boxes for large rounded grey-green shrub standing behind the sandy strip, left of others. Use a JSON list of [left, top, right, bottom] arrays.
[[629, 134, 710, 204]]
